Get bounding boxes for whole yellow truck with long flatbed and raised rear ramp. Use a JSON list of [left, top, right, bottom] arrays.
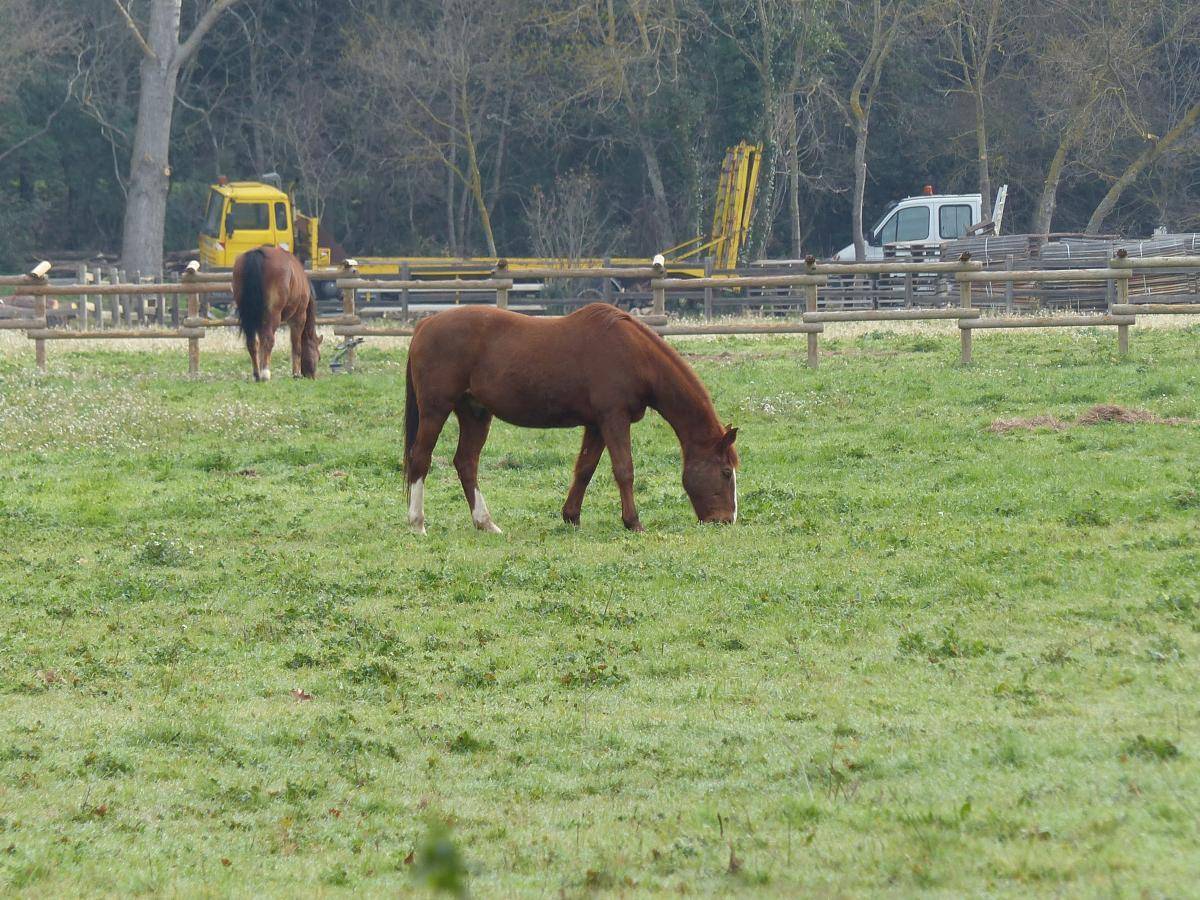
[[199, 142, 762, 285]]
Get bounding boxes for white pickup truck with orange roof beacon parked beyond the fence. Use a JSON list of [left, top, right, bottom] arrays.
[[833, 185, 1008, 263]]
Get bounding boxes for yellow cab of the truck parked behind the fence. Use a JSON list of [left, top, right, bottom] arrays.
[[200, 181, 329, 270]]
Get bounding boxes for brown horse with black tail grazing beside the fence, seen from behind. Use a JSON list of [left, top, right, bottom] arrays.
[[233, 246, 322, 382]]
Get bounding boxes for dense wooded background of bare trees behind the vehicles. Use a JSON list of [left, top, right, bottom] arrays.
[[0, 0, 1200, 271]]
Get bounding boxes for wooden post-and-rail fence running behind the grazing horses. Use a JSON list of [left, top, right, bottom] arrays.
[[0, 251, 1200, 374]]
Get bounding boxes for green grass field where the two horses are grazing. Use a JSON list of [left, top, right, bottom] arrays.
[[0, 325, 1200, 896]]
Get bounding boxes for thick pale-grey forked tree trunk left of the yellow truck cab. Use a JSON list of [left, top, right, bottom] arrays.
[[112, 0, 238, 274]]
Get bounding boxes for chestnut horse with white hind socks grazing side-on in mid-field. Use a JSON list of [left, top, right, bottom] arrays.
[[404, 304, 738, 534]]
